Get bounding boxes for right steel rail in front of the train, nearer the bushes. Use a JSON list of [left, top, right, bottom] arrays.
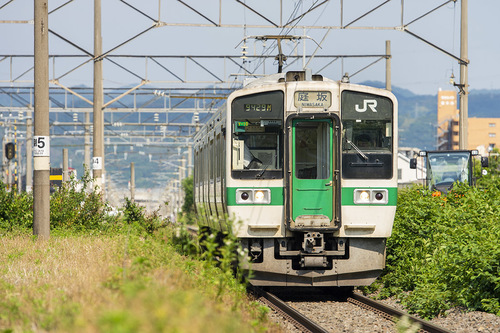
[[347, 293, 452, 333]]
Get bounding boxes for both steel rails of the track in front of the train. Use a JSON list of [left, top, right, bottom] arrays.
[[251, 287, 451, 333]]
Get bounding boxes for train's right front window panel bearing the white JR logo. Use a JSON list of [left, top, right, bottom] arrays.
[[341, 91, 394, 179]]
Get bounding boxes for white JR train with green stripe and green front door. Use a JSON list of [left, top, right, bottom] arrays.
[[194, 72, 398, 287]]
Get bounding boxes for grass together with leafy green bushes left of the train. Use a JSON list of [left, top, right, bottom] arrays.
[[0, 178, 274, 332]]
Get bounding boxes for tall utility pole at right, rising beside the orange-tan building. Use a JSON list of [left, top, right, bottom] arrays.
[[458, 0, 469, 149]]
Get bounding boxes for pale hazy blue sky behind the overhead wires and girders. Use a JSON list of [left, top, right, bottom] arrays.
[[0, 0, 500, 94]]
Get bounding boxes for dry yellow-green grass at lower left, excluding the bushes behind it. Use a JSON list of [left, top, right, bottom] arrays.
[[0, 230, 277, 332]]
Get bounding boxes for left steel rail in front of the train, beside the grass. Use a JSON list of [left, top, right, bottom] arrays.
[[249, 286, 329, 333]]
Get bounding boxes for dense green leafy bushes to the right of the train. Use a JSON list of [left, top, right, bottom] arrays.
[[380, 172, 500, 318]]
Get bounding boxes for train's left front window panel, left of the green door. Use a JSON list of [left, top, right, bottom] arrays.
[[231, 91, 283, 179]]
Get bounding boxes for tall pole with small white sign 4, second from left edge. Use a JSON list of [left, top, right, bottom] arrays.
[[92, 0, 104, 193]]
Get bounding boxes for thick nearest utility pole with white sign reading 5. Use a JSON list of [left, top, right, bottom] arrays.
[[33, 0, 50, 239]]
